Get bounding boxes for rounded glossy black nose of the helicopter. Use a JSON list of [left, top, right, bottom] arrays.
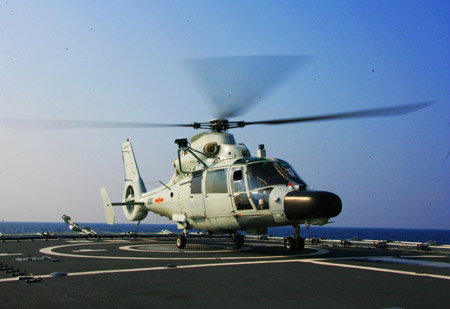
[[284, 191, 342, 220]]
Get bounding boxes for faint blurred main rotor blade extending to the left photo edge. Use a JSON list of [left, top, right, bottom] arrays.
[[0, 119, 194, 130]]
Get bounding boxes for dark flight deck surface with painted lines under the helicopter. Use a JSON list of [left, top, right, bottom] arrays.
[[0, 238, 450, 308]]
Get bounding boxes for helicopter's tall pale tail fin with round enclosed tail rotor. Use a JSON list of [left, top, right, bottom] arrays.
[[122, 140, 148, 221]]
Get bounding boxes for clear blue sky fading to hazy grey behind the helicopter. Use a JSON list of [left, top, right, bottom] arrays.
[[0, 0, 450, 229]]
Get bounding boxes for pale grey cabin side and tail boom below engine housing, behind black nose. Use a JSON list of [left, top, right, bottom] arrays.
[[141, 160, 292, 231]]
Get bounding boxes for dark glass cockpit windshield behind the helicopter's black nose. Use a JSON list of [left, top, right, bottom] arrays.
[[247, 160, 306, 191]]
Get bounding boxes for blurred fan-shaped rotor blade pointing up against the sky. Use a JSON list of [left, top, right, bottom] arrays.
[[183, 55, 311, 118]]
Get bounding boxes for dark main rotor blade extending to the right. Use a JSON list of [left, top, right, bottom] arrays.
[[244, 101, 435, 126]]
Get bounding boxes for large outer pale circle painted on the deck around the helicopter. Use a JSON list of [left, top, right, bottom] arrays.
[[39, 242, 329, 260]]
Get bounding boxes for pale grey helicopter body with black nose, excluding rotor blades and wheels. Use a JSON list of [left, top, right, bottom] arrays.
[[124, 132, 341, 233]]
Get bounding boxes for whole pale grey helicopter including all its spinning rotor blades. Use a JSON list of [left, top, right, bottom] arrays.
[[1, 55, 434, 252]]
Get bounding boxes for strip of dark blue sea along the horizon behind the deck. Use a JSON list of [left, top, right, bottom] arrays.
[[0, 222, 450, 244]]
